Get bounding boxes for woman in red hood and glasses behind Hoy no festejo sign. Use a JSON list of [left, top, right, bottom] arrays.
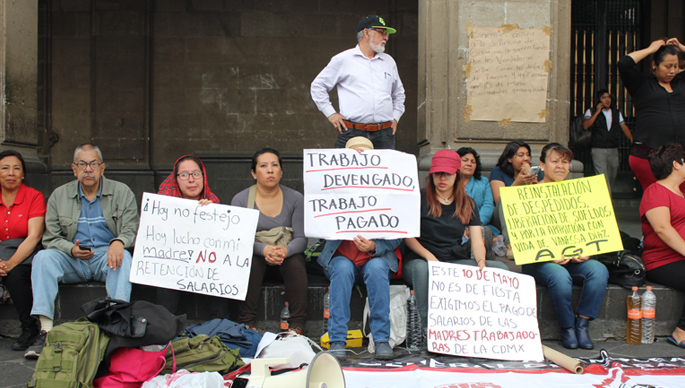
[[157, 155, 228, 318]]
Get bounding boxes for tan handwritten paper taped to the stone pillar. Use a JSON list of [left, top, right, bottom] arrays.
[[466, 27, 552, 123]]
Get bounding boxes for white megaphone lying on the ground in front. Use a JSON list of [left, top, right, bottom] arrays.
[[246, 352, 345, 388]]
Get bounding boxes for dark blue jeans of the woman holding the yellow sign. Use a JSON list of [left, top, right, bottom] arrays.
[[521, 259, 609, 329]]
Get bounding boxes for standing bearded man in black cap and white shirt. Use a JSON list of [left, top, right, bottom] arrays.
[[311, 15, 405, 149]]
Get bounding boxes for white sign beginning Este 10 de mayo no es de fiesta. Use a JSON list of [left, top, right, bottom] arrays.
[[427, 261, 543, 361]]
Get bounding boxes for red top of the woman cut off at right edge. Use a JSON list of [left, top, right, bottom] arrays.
[[640, 183, 685, 271]]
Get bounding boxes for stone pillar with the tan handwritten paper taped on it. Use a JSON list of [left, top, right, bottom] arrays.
[[417, 0, 582, 171]]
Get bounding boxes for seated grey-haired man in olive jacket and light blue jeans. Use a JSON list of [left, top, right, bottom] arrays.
[[24, 144, 138, 358]]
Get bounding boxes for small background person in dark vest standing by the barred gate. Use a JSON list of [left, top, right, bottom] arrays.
[[583, 89, 633, 195]]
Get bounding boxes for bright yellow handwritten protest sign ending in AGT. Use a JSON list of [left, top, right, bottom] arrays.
[[500, 175, 623, 265]]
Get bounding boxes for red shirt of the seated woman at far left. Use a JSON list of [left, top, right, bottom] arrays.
[[0, 183, 45, 241]]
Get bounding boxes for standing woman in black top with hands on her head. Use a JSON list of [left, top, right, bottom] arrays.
[[618, 38, 685, 189]]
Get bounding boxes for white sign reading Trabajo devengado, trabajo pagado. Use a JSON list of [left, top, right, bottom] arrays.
[[304, 148, 421, 240]]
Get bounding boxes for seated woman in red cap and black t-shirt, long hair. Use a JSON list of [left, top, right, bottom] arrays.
[[402, 150, 508, 327]]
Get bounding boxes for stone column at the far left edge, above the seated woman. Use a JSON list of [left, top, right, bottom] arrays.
[[0, 0, 38, 150]]
